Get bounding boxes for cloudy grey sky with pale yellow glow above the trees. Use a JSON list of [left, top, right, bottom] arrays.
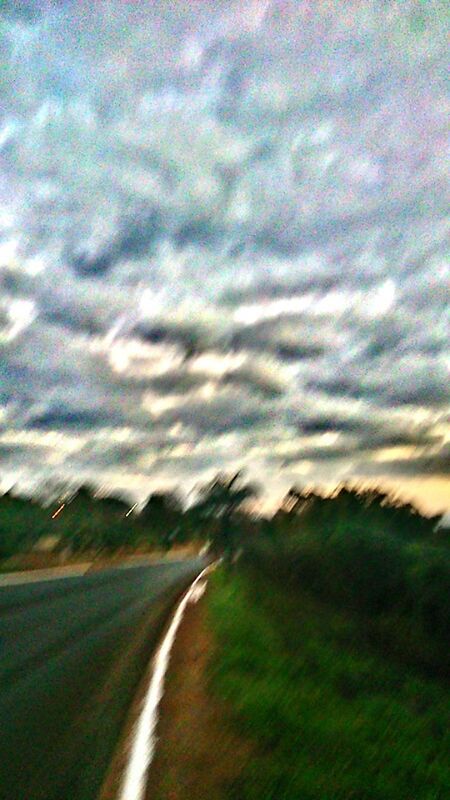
[[0, 0, 450, 512]]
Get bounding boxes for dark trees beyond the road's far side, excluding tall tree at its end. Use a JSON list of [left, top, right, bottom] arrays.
[[0, 487, 201, 569]]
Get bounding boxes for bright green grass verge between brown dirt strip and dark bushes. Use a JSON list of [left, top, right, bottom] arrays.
[[208, 572, 450, 800]]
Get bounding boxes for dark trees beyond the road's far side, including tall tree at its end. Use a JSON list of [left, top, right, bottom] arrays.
[[0, 474, 260, 570]]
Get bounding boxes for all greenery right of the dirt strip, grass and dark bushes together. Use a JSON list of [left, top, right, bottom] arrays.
[[204, 488, 450, 800]]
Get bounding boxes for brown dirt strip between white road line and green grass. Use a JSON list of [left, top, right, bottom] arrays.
[[146, 598, 252, 800]]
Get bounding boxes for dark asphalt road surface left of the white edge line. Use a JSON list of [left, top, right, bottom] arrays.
[[0, 559, 202, 800]]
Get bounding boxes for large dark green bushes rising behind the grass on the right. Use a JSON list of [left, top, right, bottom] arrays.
[[246, 492, 450, 675]]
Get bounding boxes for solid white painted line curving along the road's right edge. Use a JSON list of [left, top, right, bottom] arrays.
[[118, 564, 216, 800]]
